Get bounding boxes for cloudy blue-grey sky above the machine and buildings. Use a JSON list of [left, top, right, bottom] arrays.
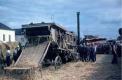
[[0, 0, 122, 38]]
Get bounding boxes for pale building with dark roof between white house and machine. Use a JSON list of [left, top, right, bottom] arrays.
[[14, 29, 27, 46]]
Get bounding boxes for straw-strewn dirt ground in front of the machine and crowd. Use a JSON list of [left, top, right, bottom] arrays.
[[0, 54, 122, 80]]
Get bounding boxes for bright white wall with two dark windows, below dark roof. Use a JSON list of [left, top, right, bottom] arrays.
[[0, 29, 15, 42]]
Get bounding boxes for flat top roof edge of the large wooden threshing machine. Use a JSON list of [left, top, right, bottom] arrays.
[[22, 22, 66, 31]]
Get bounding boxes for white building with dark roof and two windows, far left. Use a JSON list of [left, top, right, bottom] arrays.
[[0, 23, 15, 43]]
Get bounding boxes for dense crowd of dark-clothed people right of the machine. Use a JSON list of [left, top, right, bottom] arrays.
[[78, 41, 122, 64]]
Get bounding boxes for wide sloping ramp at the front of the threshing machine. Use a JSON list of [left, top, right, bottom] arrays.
[[5, 42, 50, 69]]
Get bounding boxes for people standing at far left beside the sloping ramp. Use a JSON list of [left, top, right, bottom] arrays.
[[0, 46, 22, 68]]
